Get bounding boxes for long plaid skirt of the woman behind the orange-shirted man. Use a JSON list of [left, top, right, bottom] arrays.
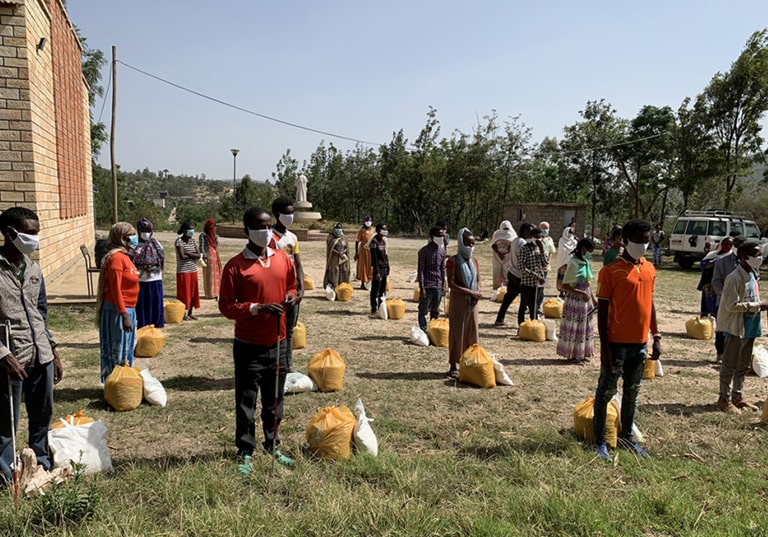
[[557, 282, 595, 360]]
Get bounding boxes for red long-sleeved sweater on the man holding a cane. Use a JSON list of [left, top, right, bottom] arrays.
[[219, 250, 296, 346]]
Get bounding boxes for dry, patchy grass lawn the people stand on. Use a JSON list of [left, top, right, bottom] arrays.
[[0, 239, 768, 537]]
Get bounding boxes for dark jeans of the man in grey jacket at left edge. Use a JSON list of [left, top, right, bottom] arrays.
[[0, 359, 53, 487]]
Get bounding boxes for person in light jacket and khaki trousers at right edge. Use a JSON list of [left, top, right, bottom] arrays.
[[717, 242, 768, 414]]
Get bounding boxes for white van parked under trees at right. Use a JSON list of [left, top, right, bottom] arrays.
[[669, 210, 762, 268]]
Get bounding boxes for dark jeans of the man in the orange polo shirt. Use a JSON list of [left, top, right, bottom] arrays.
[[592, 343, 648, 444]]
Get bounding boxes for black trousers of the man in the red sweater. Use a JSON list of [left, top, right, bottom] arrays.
[[232, 339, 287, 455]]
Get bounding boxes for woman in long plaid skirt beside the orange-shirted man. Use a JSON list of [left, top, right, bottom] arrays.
[[557, 238, 597, 364]]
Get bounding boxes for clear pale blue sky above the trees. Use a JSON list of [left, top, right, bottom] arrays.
[[67, 0, 768, 184]]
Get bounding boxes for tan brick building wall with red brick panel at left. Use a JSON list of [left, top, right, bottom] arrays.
[[0, 0, 94, 281]]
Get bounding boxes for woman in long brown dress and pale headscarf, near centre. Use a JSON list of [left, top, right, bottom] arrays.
[[446, 227, 482, 380]]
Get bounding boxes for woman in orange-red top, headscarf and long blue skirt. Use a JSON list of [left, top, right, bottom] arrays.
[[96, 222, 139, 382]]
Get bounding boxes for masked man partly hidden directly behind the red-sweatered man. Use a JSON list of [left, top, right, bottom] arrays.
[[269, 196, 304, 371]]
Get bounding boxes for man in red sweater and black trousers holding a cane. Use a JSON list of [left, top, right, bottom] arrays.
[[219, 207, 296, 466]]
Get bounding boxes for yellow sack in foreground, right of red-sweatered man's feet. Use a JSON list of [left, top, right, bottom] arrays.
[[306, 406, 357, 460]]
